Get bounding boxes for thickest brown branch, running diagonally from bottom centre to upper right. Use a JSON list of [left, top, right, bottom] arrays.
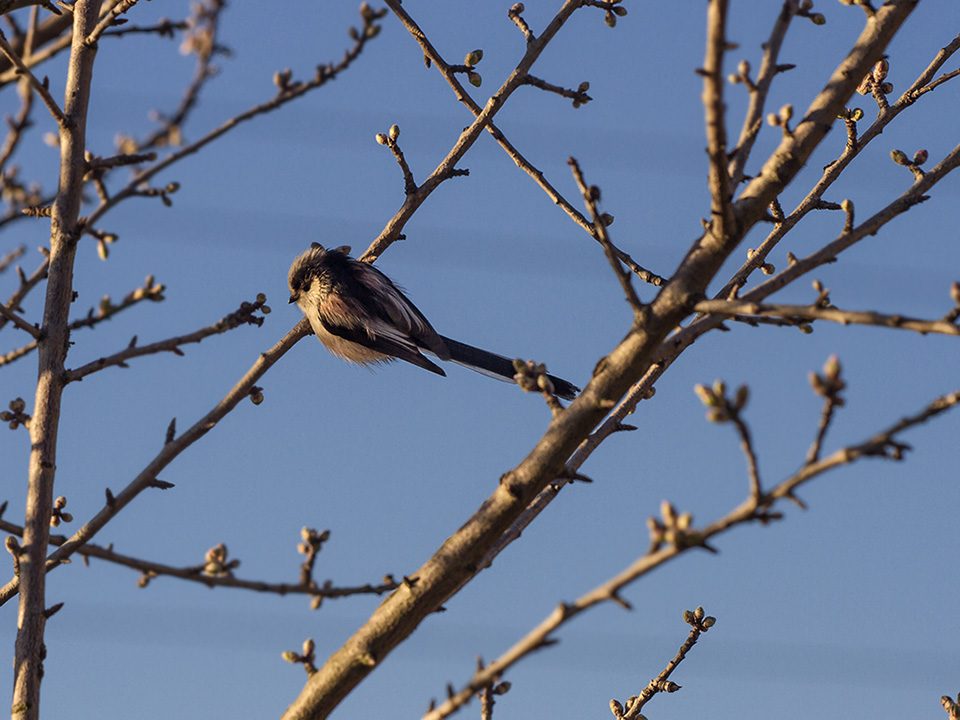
[[284, 7, 916, 720]]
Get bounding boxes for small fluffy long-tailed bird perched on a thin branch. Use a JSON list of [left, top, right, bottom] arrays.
[[287, 243, 579, 400]]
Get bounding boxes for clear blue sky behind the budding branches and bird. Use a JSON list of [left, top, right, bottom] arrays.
[[0, 0, 960, 720]]
